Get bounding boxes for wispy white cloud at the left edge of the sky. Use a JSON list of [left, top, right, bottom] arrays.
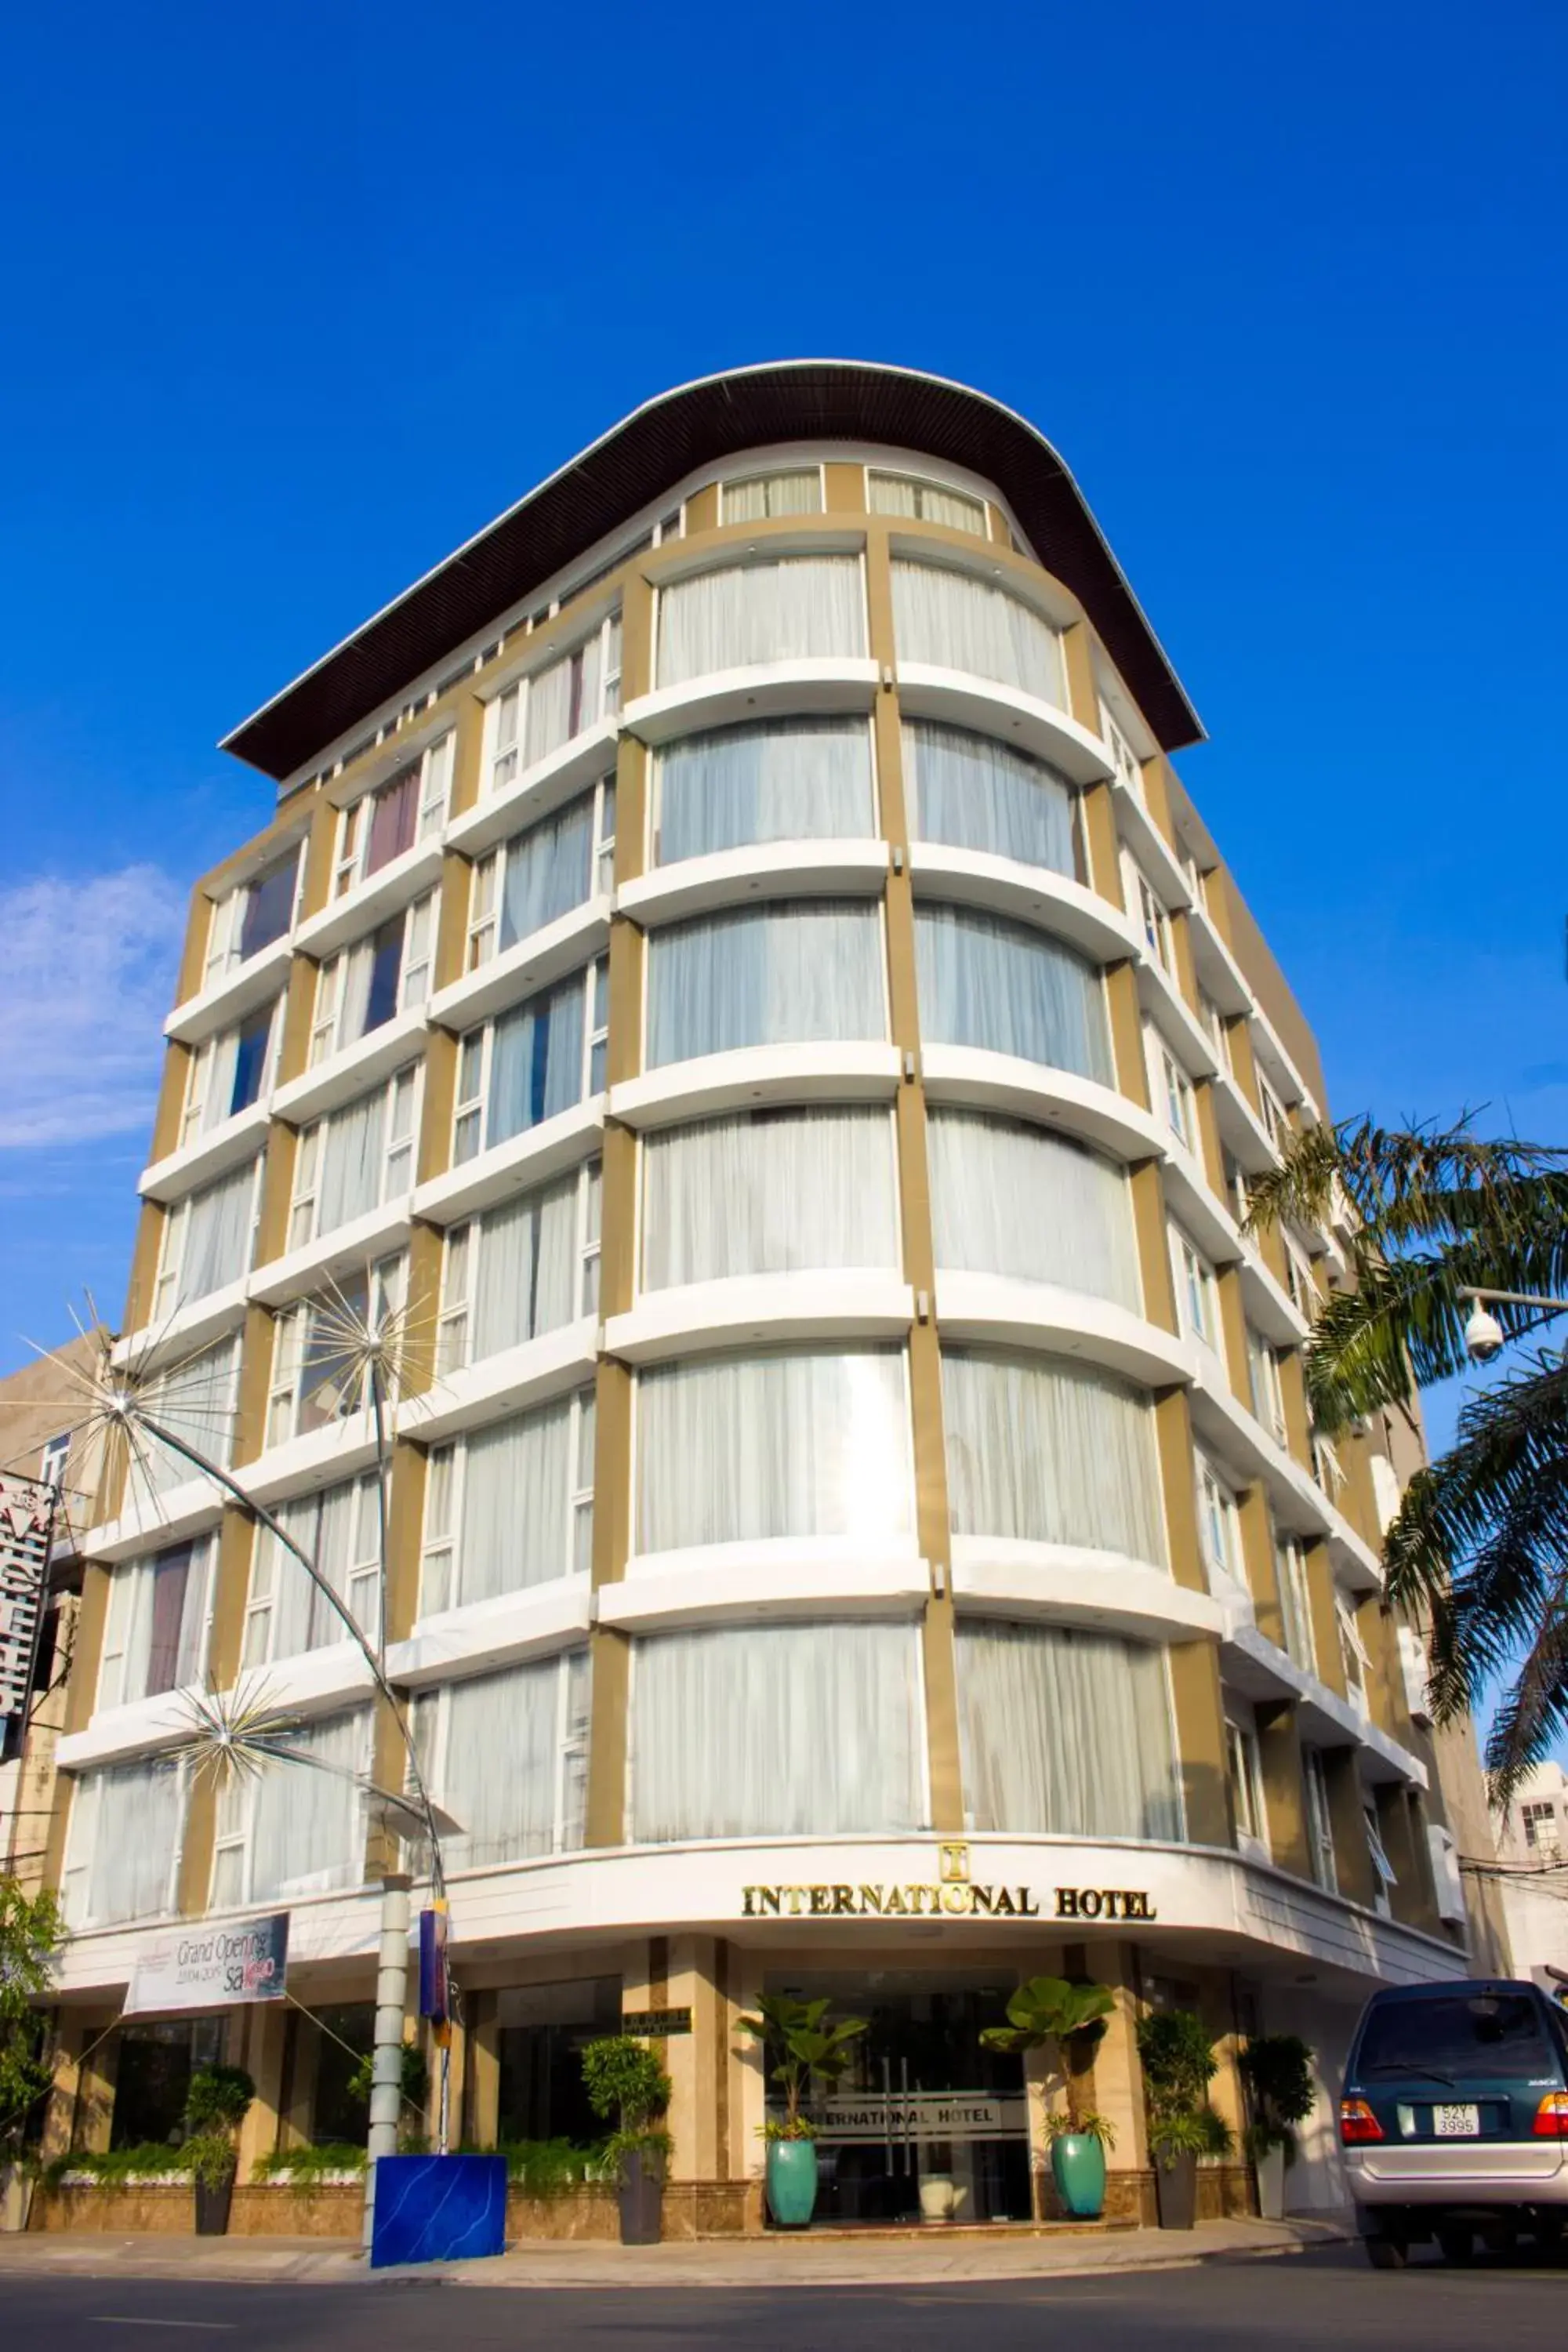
[[0, 866, 186, 1150]]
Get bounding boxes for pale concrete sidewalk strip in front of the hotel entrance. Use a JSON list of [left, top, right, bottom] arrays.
[[0, 2220, 1349, 2291]]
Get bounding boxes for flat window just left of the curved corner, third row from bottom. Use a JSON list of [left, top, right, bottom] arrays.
[[435, 1160, 602, 1376]]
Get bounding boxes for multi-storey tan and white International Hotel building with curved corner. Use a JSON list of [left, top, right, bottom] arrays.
[[34, 362, 1493, 2230]]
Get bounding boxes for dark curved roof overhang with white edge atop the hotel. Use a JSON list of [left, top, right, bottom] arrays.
[[221, 360, 1203, 783]]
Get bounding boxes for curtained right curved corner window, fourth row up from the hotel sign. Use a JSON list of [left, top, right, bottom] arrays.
[[914, 906, 1114, 1087]]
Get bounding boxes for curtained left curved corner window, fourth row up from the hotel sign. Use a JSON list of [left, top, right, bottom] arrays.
[[649, 898, 886, 1068]]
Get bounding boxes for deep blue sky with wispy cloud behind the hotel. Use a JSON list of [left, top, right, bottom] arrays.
[[0, 0, 1568, 1425]]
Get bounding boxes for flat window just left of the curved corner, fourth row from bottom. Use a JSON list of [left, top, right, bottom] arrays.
[[452, 962, 609, 1164]]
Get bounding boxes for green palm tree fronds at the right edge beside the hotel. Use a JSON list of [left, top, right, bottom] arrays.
[[1246, 1120, 1568, 1802]]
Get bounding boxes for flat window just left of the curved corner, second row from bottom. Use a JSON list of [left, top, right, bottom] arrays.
[[419, 1388, 595, 1616]]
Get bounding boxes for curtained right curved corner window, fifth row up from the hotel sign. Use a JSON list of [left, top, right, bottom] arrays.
[[902, 720, 1076, 875]]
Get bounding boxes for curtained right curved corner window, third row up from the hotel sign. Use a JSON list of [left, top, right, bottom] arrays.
[[926, 1110, 1138, 1310]]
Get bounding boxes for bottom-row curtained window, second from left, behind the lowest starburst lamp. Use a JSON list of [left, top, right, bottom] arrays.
[[209, 1708, 372, 1910]]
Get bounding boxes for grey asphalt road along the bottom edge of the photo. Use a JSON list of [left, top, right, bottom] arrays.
[[0, 2249, 1568, 2352]]
